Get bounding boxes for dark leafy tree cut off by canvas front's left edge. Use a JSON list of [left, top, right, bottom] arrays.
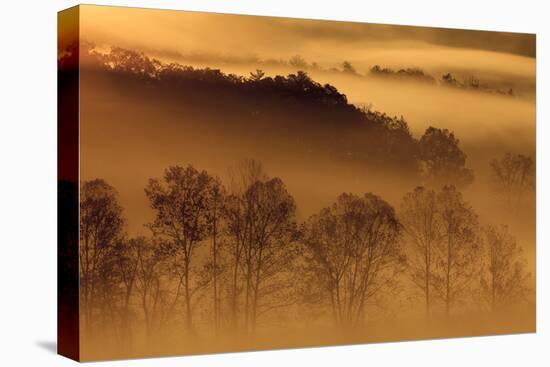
[[80, 179, 124, 334]]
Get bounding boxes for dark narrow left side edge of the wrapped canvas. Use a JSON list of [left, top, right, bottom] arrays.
[[57, 7, 80, 360]]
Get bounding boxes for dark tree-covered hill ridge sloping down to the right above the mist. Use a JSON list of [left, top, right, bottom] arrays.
[[59, 43, 474, 184]]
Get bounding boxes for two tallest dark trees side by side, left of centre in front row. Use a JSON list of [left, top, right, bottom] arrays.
[[142, 161, 298, 332]]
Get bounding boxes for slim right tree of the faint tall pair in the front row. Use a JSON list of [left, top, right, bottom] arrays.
[[434, 186, 480, 315]]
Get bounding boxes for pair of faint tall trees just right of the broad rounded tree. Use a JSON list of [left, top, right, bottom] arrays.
[[400, 186, 482, 317]]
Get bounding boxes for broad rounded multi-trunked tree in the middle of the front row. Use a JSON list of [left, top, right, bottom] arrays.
[[303, 194, 404, 326]]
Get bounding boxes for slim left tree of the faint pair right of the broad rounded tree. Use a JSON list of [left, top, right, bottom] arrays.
[[399, 187, 442, 318]]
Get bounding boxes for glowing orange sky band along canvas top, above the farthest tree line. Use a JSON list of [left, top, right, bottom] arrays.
[[81, 5, 535, 63]]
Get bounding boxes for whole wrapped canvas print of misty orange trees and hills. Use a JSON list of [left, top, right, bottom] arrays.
[[58, 5, 536, 361]]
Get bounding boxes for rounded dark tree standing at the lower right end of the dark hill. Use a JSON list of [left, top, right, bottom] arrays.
[[419, 126, 474, 188]]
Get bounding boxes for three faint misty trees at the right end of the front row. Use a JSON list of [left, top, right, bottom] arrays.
[[399, 186, 530, 317]]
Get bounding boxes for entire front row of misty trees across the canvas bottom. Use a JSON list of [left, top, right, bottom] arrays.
[[80, 160, 529, 348]]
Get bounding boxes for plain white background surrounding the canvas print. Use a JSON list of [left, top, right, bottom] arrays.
[[0, 0, 550, 367]]
